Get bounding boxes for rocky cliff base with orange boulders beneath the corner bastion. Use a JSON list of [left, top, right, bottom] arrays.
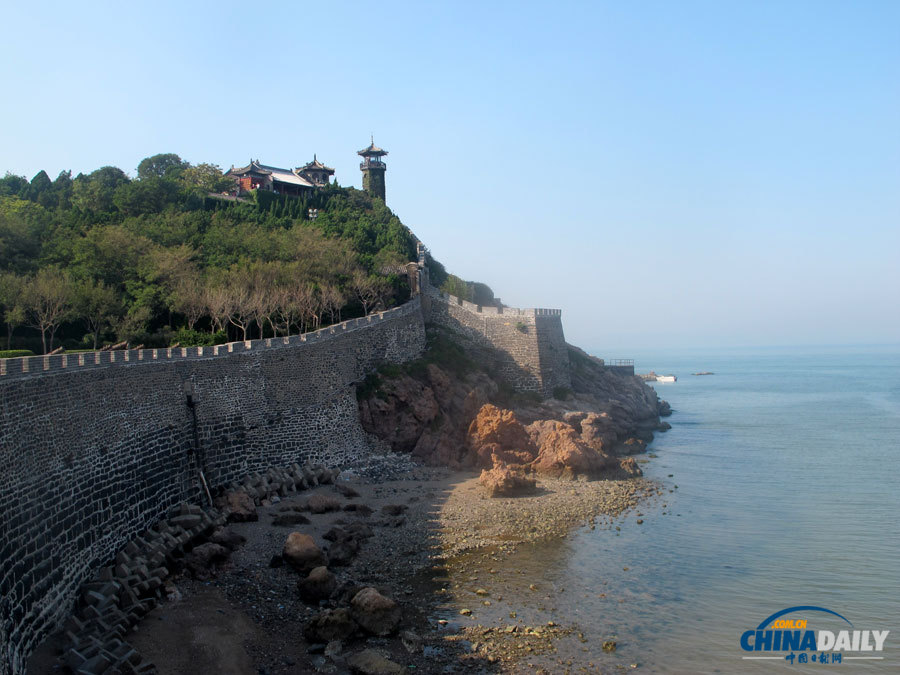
[[359, 329, 668, 478]]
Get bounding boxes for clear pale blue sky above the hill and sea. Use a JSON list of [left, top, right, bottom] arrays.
[[0, 0, 900, 358]]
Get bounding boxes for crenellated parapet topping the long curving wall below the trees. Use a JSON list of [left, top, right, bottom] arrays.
[[0, 297, 421, 379]]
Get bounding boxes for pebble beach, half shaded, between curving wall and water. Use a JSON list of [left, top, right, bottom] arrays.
[[29, 454, 658, 675]]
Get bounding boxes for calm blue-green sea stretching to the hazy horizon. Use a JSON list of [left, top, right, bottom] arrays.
[[458, 346, 900, 673]]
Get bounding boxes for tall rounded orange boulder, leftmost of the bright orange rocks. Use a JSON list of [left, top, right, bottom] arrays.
[[467, 403, 537, 469]]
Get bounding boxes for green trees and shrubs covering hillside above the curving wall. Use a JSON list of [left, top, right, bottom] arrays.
[[0, 153, 415, 353]]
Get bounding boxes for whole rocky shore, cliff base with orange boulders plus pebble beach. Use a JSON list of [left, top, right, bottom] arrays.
[[29, 333, 671, 675]]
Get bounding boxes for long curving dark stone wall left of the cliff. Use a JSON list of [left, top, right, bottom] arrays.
[[0, 298, 425, 674]]
